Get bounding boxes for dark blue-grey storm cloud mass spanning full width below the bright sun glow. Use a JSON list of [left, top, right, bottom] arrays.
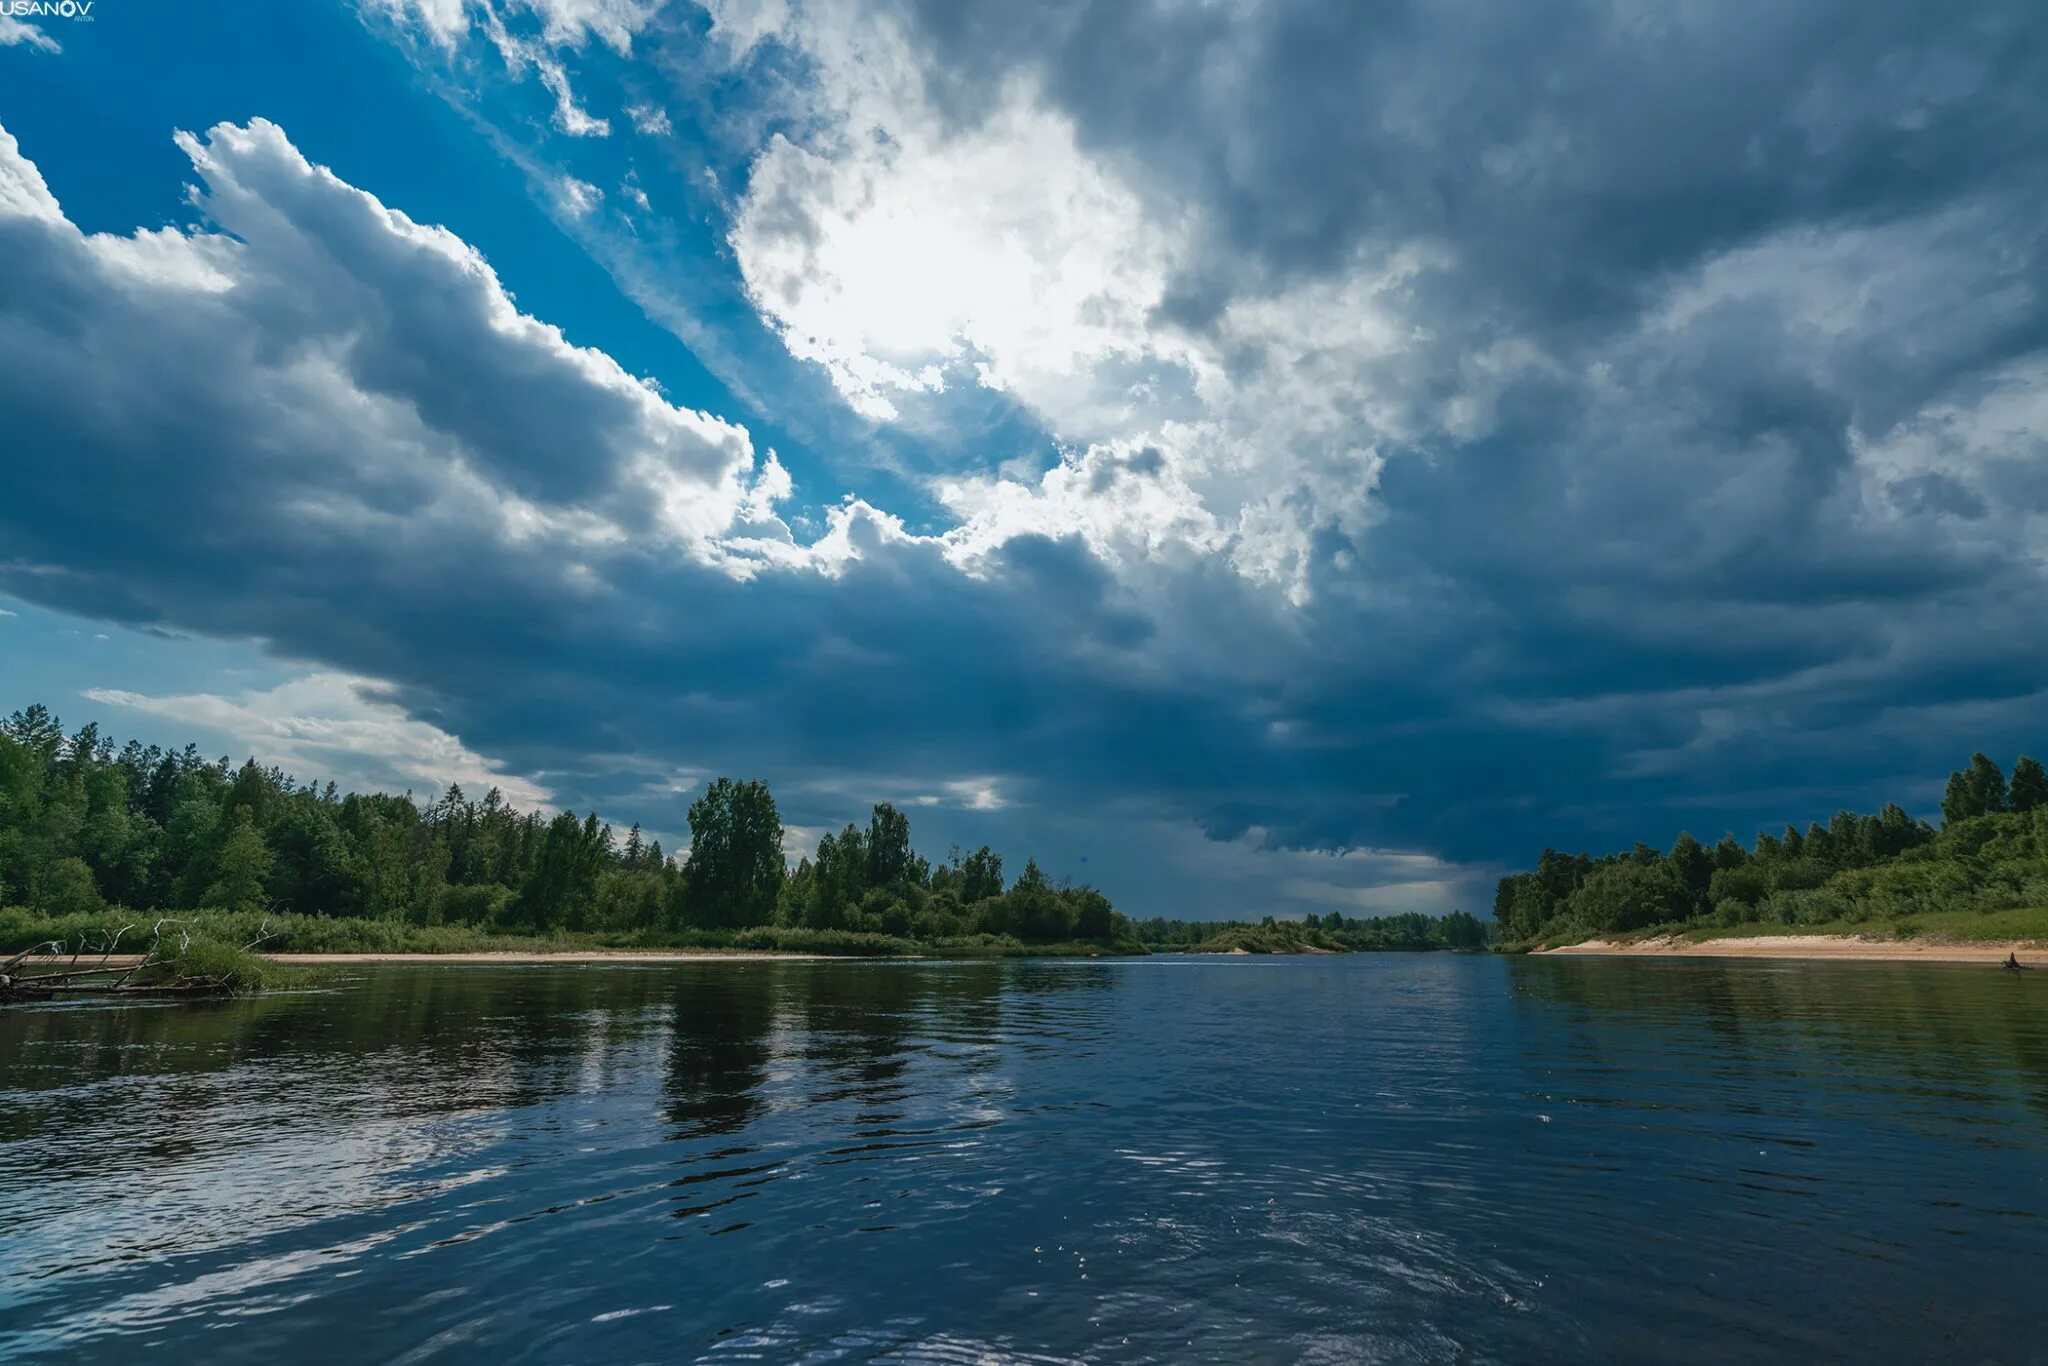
[[12, 4, 2048, 911]]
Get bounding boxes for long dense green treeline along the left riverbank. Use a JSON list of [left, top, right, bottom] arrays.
[[0, 707, 1128, 944]]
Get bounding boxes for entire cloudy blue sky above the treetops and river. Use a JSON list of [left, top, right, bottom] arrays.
[[0, 0, 2048, 917]]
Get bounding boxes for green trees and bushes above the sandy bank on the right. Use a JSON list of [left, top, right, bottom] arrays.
[[1493, 754, 2048, 942]]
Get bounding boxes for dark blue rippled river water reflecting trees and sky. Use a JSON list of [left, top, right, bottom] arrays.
[[0, 954, 2048, 1364]]
